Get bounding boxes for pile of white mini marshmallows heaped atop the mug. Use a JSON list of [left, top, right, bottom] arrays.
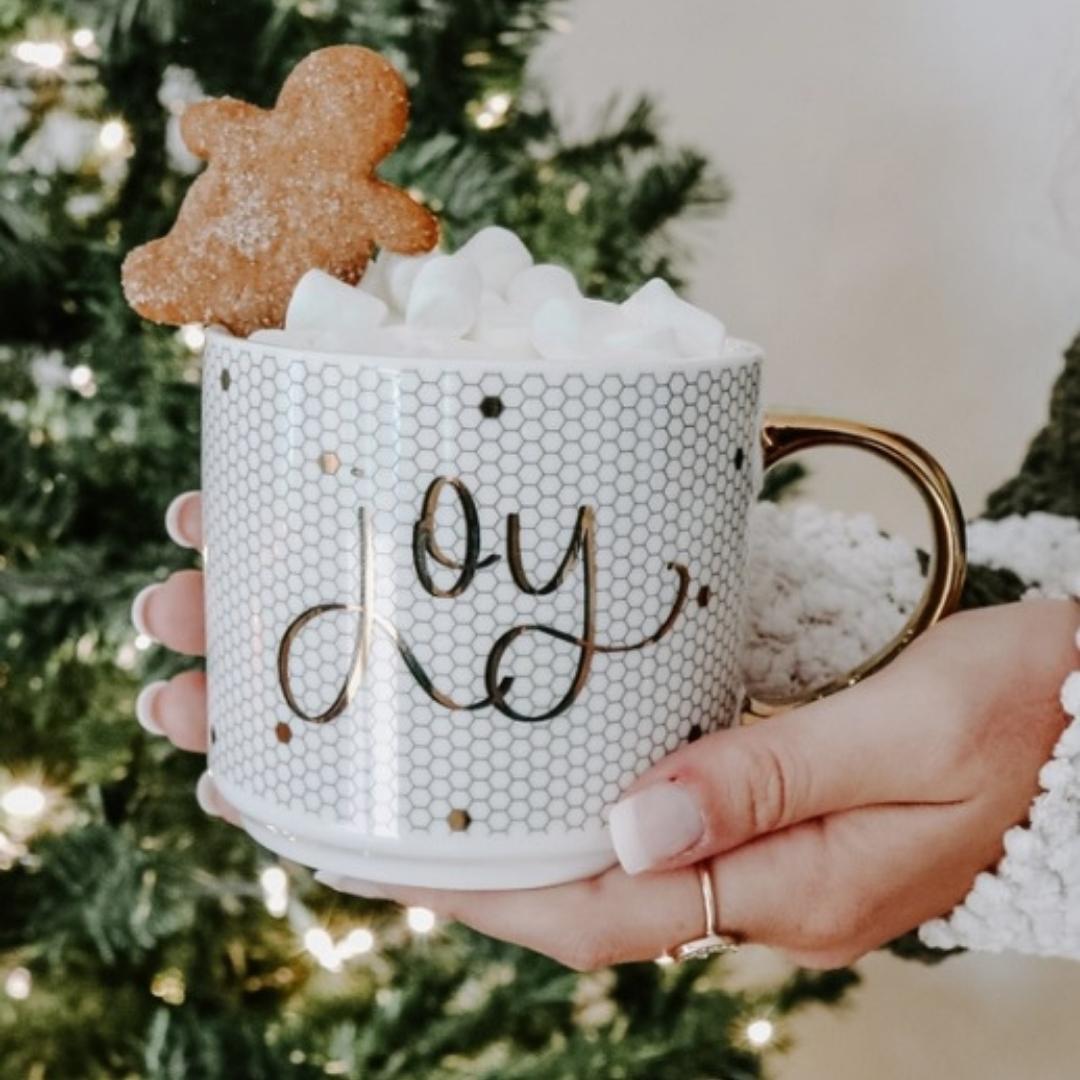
[[251, 227, 725, 362]]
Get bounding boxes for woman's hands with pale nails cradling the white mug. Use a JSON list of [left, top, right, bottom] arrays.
[[135, 495, 1080, 970]]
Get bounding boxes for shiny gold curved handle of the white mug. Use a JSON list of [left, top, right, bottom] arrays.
[[742, 413, 967, 725]]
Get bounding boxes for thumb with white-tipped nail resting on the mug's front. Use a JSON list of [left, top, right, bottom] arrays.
[[609, 673, 942, 874]]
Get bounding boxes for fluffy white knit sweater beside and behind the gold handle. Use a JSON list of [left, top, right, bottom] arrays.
[[743, 503, 1080, 959]]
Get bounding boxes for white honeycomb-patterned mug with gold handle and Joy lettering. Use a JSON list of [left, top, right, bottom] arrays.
[[203, 332, 963, 889]]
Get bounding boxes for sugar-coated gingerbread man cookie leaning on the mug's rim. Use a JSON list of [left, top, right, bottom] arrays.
[[123, 45, 438, 335]]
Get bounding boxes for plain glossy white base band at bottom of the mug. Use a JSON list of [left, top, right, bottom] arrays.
[[215, 775, 617, 891]]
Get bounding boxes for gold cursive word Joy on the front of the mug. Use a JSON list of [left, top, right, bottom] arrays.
[[278, 476, 690, 724]]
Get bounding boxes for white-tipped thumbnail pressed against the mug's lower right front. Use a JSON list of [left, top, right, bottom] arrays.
[[608, 783, 705, 874]]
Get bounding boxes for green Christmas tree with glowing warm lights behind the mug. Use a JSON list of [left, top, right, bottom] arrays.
[[0, 0, 1078, 1080]]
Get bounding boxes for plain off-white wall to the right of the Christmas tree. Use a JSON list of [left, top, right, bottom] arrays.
[[539, 0, 1080, 1080]]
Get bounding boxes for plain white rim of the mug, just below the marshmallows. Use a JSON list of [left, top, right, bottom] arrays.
[[205, 326, 765, 376]]
